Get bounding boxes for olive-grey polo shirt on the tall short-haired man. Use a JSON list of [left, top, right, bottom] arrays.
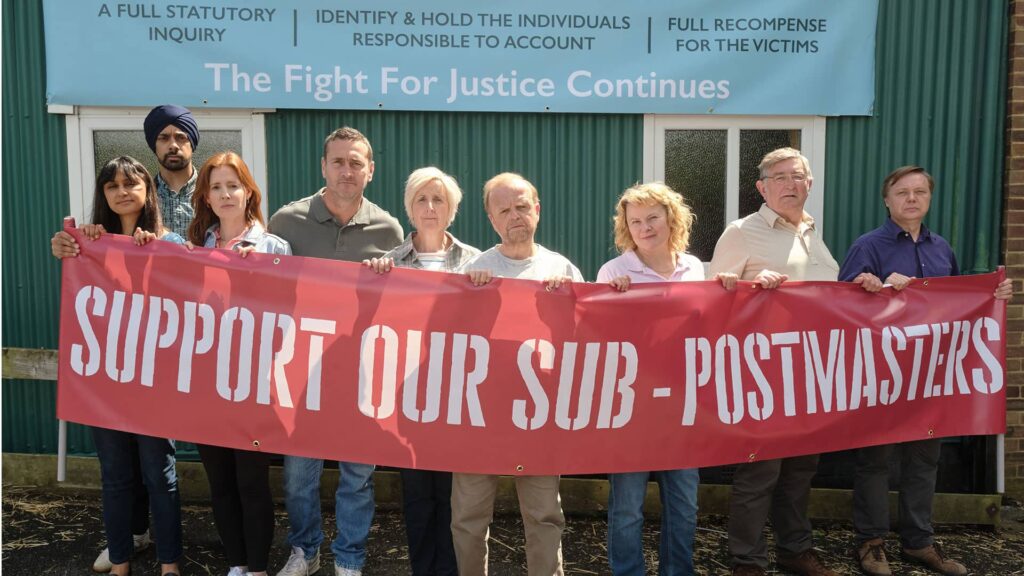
[[270, 189, 402, 262]]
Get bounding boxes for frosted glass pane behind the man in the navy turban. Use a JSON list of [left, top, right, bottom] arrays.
[[90, 130, 242, 179]]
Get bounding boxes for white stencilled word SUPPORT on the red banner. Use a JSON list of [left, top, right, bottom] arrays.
[[70, 286, 335, 410]]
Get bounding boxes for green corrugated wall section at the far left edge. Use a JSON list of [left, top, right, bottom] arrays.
[[2, 0, 97, 453]]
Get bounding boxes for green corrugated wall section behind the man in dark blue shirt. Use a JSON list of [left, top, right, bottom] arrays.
[[825, 0, 1009, 273]]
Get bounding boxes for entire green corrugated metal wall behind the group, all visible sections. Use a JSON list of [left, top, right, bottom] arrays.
[[2, 0, 1008, 453]]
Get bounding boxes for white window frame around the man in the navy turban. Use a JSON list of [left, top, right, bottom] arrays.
[[48, 106, 273, 224]]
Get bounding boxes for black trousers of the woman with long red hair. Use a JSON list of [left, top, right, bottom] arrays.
[[197, 444, 273, 572]]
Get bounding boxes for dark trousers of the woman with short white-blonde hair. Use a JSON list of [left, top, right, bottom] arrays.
[[401, 468, 459, 576]]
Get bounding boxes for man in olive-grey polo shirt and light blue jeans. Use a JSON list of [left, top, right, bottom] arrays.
[[270, 127, 403, 576]]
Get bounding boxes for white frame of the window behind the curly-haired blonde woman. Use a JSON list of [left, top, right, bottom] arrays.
[[643, 114, 825, 234]]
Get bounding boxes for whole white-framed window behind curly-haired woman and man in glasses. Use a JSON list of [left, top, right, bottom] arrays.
[[644, 115, 825, 262]]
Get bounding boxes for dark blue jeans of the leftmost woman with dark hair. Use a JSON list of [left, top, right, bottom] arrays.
[[92, 427, 181, 564]]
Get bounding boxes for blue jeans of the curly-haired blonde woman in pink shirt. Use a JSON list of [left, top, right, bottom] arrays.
[[608, 468, 700, 576]]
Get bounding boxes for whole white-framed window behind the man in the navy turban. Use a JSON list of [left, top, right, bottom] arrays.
[[50, 106, 269, 223]]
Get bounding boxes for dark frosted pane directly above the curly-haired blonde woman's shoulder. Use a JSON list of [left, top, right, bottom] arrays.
[[665, 130, 728, 262]]
